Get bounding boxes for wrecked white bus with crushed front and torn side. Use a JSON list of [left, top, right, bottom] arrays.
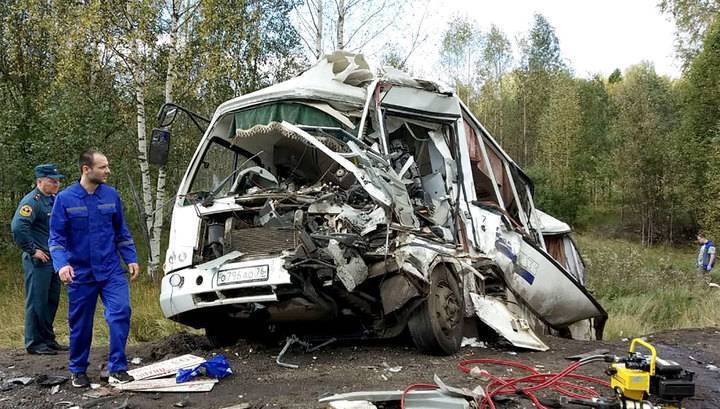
[[151, 52, 607, 354]]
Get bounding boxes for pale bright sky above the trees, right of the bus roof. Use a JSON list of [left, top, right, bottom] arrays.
[[400, 0, 680, 78]]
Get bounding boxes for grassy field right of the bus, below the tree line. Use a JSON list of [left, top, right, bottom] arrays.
[[577, 235, 720, 339]]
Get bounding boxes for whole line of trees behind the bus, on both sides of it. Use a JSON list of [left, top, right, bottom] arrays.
[[0, 0, 720, 273]]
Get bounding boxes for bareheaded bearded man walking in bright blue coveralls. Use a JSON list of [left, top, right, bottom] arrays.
[[49, 150, 140, 388]]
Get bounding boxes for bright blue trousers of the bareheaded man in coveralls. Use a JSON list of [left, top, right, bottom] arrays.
[[68, 274, 130, 373]]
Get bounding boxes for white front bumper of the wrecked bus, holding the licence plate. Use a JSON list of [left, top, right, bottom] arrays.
[[160, 257, 291, 318]]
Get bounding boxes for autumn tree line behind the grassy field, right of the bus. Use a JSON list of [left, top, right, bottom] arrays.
[[440, 5, 720, 245]]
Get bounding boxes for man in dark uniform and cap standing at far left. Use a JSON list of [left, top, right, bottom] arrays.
[[11, 163, 68, 355]]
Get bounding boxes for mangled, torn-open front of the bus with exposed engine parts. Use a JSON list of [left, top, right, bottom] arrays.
[[183, 118, 464, 353]]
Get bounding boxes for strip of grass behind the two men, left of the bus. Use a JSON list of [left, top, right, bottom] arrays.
[[0, 245, 194, 348]]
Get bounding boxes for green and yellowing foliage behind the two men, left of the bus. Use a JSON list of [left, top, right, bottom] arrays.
[[0, 0, 305, 255]]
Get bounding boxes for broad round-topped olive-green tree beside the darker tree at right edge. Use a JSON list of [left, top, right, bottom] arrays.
[[611, 63, 687, 243]]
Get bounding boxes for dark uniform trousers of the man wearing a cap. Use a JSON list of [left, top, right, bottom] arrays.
[[22, 253, 60, 350]]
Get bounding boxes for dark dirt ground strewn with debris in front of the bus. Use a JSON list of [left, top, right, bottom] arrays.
[[0, 328, 720, 409]]
